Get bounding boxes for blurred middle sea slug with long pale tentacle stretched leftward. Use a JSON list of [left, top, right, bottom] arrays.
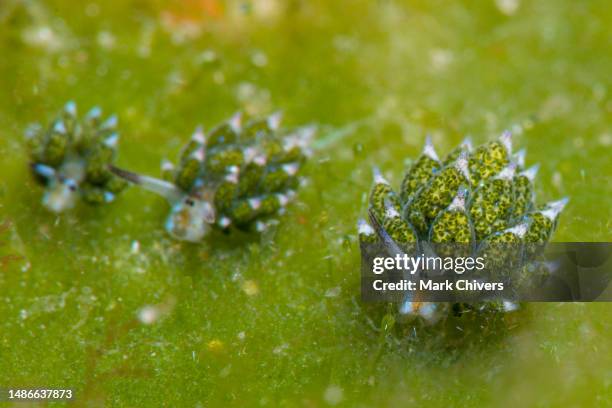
[[112, 114, 314, 242]]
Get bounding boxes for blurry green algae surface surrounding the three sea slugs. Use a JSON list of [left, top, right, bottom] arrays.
[[0, 0, 612, 407]]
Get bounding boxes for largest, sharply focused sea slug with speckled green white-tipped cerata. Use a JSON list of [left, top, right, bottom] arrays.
[[359, 132, 567, 322]]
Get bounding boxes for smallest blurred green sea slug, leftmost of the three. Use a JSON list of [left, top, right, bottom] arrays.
[[26, 102, 127, 213]]
